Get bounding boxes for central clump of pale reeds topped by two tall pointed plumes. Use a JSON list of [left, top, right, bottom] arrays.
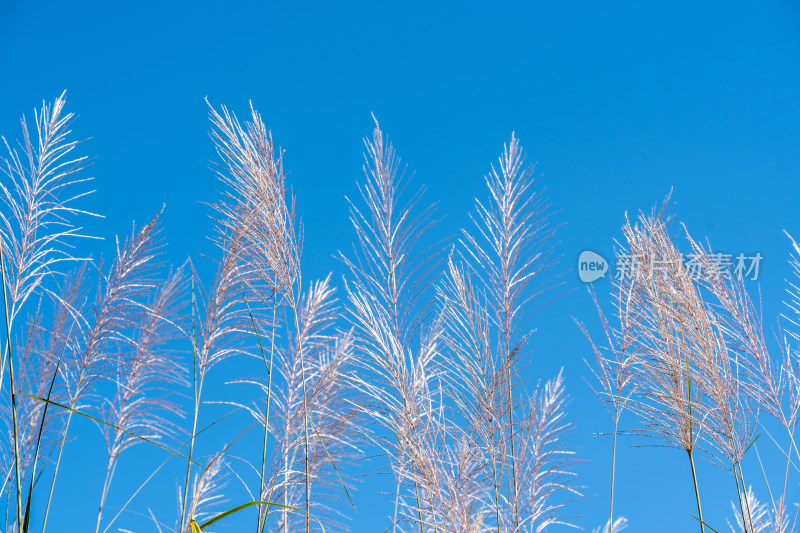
[[343, 124, 578, 532]]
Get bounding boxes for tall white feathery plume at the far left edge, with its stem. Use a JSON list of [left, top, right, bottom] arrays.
[[0, 93, 97, 528]]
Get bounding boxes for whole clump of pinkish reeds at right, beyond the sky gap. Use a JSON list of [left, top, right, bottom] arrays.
[[584, 193, 798, 532]]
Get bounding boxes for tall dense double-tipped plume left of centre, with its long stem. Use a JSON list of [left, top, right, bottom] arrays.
[[210, 98, 356, 533]]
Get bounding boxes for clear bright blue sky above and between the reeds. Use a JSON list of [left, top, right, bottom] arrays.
[[0, 0, 800, 532]]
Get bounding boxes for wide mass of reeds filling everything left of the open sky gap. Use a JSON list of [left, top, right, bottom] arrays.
[[0, 95, 580, 533]]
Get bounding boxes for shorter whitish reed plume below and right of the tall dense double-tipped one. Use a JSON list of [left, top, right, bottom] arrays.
[[247, 279, 356, 531]]
